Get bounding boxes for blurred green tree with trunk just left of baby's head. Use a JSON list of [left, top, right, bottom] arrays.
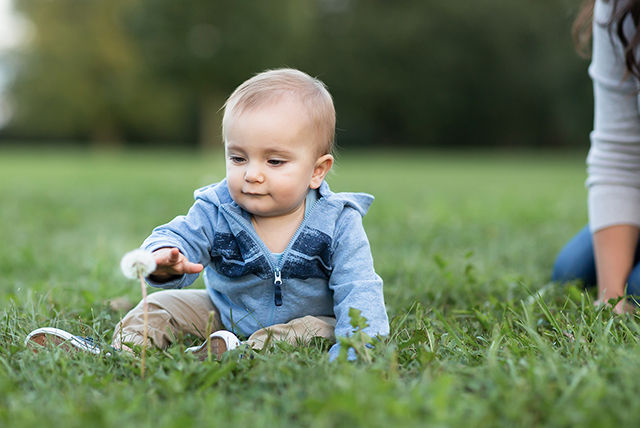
[[124, 0, 315, 147]]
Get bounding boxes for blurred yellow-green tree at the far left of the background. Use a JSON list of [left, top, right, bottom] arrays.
[[9, 0, 188, 146]]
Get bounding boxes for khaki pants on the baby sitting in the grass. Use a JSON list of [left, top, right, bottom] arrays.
[[111, 290, 336, 349]]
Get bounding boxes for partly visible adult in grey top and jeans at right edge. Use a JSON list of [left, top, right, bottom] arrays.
[[552, 0, 640, 313]]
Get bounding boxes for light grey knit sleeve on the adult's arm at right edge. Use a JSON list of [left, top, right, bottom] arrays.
[[587, 0, 640, 232]]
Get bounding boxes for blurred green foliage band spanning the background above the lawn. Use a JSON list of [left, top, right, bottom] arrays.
[[0, 0, 591, 147]]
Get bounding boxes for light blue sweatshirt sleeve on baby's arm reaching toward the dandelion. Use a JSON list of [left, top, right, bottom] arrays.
[[141, 199, 217, 288]]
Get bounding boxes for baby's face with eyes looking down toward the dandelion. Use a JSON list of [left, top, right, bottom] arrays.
[[225, 98, 321, 221]]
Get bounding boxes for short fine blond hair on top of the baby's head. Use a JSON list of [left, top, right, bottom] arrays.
[[222, 68, 336, 154]]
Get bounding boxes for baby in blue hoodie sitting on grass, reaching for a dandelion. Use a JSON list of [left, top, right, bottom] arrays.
[[30, 69, 389, 360]]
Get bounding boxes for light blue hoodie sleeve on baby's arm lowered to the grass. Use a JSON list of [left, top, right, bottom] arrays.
[[329, 209, 389, 361]]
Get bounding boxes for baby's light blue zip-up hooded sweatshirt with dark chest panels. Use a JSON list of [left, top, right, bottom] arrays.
[[142, 180, 389, 360]]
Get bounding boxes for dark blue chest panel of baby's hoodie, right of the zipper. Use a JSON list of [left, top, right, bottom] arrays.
[[282, 227, 332, 279]]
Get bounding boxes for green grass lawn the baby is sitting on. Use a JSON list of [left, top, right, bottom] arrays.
[[0, 146, 640, 427]]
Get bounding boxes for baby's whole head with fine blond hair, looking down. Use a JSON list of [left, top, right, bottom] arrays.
[[222, 69, 336, 217]]
